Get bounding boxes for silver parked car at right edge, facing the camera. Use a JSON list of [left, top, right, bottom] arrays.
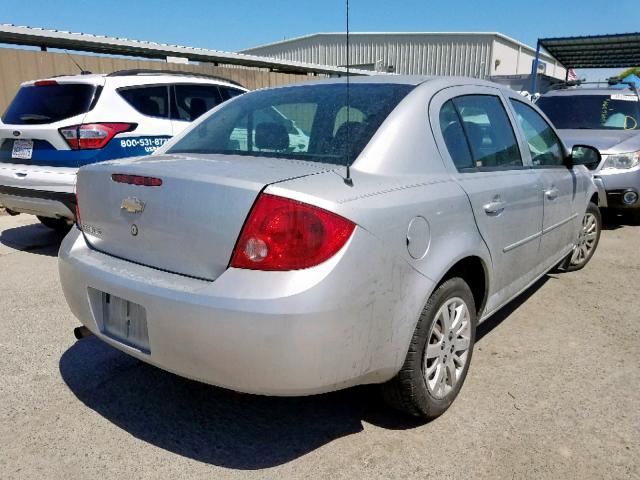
[[537, 85, 640, 218]]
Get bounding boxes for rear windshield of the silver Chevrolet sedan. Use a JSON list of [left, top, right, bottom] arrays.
[[167, 83, 413, 165]]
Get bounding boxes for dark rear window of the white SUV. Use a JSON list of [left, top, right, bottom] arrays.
[[2, 83, 96, 125]]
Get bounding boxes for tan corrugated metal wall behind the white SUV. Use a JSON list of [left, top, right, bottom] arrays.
[[0, 48, 316, 113]]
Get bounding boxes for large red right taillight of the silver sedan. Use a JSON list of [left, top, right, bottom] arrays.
[[230, 194, 355, 270]]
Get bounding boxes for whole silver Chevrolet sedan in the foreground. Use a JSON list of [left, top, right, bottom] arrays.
[[59, 76, 601, 418]]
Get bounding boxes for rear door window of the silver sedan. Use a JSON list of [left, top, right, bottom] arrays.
[[452, 95, 522, 168]]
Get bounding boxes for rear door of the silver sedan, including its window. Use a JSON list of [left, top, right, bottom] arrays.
[[430, 86, 542, 311]]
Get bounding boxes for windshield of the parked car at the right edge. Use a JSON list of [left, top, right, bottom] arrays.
[[536, 93, 640, 130]]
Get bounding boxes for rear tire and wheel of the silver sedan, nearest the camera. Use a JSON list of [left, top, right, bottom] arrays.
[[382, 277, 477, 420]]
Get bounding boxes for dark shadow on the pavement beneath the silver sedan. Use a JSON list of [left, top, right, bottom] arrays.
[[60, 276, 550, 470]]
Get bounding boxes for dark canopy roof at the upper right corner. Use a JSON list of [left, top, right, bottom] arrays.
[[538, 32, 640, 68]]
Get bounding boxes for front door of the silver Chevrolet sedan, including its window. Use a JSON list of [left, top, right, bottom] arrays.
[[509, 97, 578, 263]]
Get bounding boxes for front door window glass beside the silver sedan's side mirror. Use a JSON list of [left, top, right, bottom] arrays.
[[511, 99, 564, 166]]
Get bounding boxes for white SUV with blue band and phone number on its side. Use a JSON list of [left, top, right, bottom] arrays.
[[0, 70, 246, 231]]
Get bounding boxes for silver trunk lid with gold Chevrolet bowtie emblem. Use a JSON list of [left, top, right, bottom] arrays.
[[78, 155, 335, 280]]
